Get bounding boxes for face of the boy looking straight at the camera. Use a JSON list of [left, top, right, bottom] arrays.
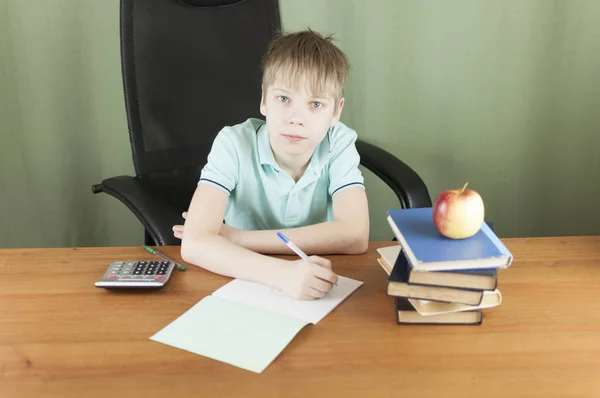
[[260, 84, 344, 156]]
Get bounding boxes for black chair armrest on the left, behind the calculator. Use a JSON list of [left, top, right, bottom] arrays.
[[92, 176, 183, 246]]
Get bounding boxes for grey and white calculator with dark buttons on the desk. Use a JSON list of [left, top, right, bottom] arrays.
[[95, 260, 176, 289]]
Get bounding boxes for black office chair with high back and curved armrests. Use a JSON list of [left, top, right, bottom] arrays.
[[92, 0, 431, 246]]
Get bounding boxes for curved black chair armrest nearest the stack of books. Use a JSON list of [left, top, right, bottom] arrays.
[[356, 140, 432, 208]]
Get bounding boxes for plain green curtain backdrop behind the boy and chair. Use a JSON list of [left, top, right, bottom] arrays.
[[0, 0, 600, 247]]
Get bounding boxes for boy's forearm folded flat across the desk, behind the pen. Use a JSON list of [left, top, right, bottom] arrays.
[[230, 221, 368, 255]]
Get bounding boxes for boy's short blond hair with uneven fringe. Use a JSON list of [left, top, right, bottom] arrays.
[[262, 29, 349, 102]]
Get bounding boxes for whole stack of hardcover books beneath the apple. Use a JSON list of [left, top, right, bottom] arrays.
[[378, 207, 513, 325]]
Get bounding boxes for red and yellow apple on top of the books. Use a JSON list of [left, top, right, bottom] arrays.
[[433, 182, 484, 239]]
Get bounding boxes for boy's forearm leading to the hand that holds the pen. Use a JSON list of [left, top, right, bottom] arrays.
[[181, 235, 285, 287]]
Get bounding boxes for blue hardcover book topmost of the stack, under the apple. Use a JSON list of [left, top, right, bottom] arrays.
[[388, 207, 513, 271]]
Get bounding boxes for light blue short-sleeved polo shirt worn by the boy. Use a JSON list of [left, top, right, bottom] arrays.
[[198, 119, 364, 230]]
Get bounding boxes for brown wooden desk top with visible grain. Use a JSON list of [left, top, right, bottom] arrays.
[[0, 237, 600, 398]]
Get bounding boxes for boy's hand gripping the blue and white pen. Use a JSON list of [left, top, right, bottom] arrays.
[[279, 256, 338, 300]]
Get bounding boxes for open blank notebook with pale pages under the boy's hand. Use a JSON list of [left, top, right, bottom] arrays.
[[150, 276, 362, 373]]
